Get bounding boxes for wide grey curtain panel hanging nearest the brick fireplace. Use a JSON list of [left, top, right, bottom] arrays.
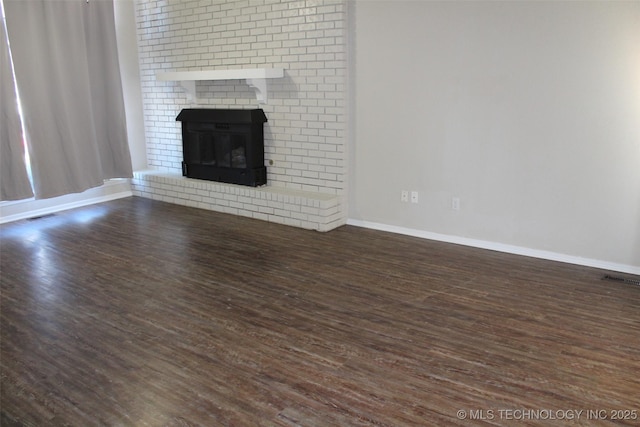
[[4, 0, 132, 198]]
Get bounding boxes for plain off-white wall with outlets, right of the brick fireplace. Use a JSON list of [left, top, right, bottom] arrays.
[[349, 1, 640, 272]]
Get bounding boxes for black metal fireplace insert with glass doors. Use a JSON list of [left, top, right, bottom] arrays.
[[176, 108, 267, 187]]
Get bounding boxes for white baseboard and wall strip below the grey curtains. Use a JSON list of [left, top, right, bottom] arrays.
[[0, 179, 133, 224]]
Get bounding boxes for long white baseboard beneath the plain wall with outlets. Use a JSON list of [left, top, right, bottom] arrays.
[[347, 219, 640, 275]]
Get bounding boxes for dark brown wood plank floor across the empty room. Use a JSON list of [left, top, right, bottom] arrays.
[[0, 198, 640, 426]]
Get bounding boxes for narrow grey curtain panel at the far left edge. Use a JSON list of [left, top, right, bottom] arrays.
[[0, 13, 33, 200]]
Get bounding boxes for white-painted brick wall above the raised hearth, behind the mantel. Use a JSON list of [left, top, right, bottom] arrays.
[[136, 0, 347, 231]]
